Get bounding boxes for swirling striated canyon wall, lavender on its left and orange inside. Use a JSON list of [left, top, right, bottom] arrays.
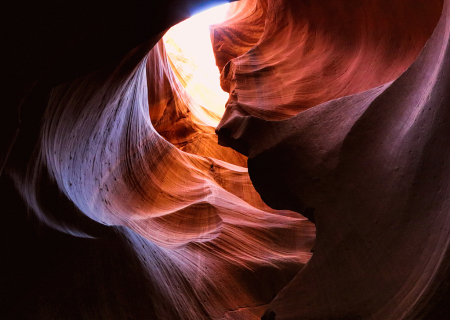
[[7, 8, 315, 319]]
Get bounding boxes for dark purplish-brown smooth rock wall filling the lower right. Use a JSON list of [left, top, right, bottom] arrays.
[[214, 1, 450, 320]]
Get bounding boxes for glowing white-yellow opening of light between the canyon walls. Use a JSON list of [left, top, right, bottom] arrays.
[[163, 3, 230, 127]]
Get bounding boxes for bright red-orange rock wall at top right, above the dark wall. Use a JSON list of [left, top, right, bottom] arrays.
[[212, 0, 442, 119]]
